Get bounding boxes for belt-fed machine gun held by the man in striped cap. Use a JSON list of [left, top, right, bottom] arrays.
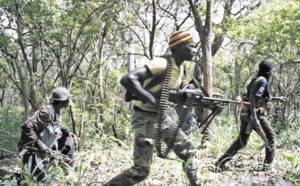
[[125, 85, 251, 158]]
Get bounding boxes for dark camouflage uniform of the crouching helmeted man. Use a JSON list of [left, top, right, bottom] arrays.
[[18, 105, 74, 181]]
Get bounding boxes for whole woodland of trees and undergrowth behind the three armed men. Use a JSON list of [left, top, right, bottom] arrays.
[[0, 0, 300, 185]]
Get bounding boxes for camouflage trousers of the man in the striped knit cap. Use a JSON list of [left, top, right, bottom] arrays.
[[105, 110, 200, 186]]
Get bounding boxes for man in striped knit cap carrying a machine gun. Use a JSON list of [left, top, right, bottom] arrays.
[[105, 31, 204, 186]]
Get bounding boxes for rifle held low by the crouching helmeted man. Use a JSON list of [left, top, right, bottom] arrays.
[[18, 146, 75, 165]]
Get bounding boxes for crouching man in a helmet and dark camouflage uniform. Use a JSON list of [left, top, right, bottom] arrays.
[[18, 87, 76, 181]]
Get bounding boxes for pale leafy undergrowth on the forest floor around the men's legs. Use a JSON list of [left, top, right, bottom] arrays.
[[1, 108, 300, 186]]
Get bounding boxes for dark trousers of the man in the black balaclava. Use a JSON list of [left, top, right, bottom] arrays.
[[216, 110, 276, 165]]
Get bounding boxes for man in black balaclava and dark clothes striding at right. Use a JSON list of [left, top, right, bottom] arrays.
[[216, 60, 276, 168]]
